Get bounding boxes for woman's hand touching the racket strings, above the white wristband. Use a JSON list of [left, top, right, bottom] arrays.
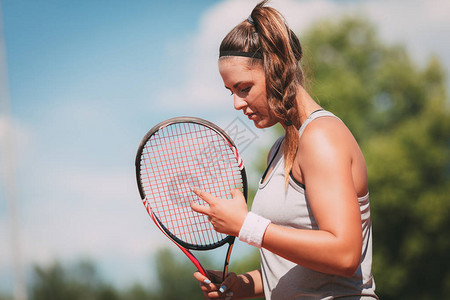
[[191, 187, 248, 236]]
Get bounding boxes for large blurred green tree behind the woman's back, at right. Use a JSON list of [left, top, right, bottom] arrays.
[[301, 18, 450, 299]]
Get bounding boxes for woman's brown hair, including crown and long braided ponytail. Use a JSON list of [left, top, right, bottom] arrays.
[[220, 0, 304, 185]]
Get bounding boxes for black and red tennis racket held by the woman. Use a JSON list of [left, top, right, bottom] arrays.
[[135, 117, 247, 279]]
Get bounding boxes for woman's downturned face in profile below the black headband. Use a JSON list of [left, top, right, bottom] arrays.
[[219, 57, 279, 128]]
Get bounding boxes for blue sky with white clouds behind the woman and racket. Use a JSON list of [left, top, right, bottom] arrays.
[[0, 0, 450, 292]]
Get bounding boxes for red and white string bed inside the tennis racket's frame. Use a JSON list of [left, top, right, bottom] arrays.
[[141, 123, 243, 246]]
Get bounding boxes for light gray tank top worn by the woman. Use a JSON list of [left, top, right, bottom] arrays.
[[252, 110, 378, 299]]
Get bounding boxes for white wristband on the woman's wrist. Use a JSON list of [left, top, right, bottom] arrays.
[[239, 212, 270, 248]]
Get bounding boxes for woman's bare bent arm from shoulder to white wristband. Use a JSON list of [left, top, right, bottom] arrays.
[[263, 118, 362, 276]]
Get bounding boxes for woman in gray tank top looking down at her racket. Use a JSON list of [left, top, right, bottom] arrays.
[[191, 1, 377, 299]]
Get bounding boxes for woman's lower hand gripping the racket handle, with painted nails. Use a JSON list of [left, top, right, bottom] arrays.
[[194, 270, 238, 300]]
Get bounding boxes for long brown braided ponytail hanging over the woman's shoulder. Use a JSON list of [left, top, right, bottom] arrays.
[[251, 1, 303, 185]]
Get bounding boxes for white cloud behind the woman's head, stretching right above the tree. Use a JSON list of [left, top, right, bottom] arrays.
[[164, 0, 450, 110]]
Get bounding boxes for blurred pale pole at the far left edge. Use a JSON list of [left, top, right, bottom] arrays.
[[0, 0, 27, 300]]
